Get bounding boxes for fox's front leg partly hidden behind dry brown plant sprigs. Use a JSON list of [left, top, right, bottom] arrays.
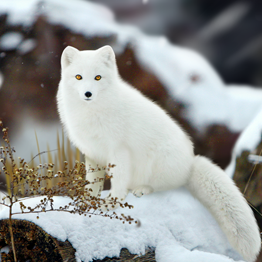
[[85, 156, 105, 197]]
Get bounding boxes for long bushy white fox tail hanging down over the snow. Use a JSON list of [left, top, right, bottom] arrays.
[[188, 156, 261, 262]]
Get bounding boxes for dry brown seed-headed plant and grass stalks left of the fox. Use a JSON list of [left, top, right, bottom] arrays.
[[0, 120, 138, 261]]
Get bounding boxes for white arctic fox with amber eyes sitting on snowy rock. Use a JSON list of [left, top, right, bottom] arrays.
[[57, 46, 261, 262]]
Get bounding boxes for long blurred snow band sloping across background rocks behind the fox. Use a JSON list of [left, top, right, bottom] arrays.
[[0, 0, 262, 132]]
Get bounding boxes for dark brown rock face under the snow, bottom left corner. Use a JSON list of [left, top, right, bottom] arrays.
[[0, 219, 76, 262]]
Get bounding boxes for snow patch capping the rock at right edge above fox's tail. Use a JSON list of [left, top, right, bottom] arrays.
[[225, 106, 262, 177]]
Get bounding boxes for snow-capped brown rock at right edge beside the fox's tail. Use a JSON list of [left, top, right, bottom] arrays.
[[225, 107, 262, 218]]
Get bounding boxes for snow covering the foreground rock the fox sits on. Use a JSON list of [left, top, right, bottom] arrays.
[[0, 188, 244, 262]]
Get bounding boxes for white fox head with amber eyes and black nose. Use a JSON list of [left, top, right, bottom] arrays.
[[61, 45, 118, 102]]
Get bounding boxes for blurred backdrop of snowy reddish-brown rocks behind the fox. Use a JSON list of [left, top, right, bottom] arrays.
[[0, 0, 262, 260]]
